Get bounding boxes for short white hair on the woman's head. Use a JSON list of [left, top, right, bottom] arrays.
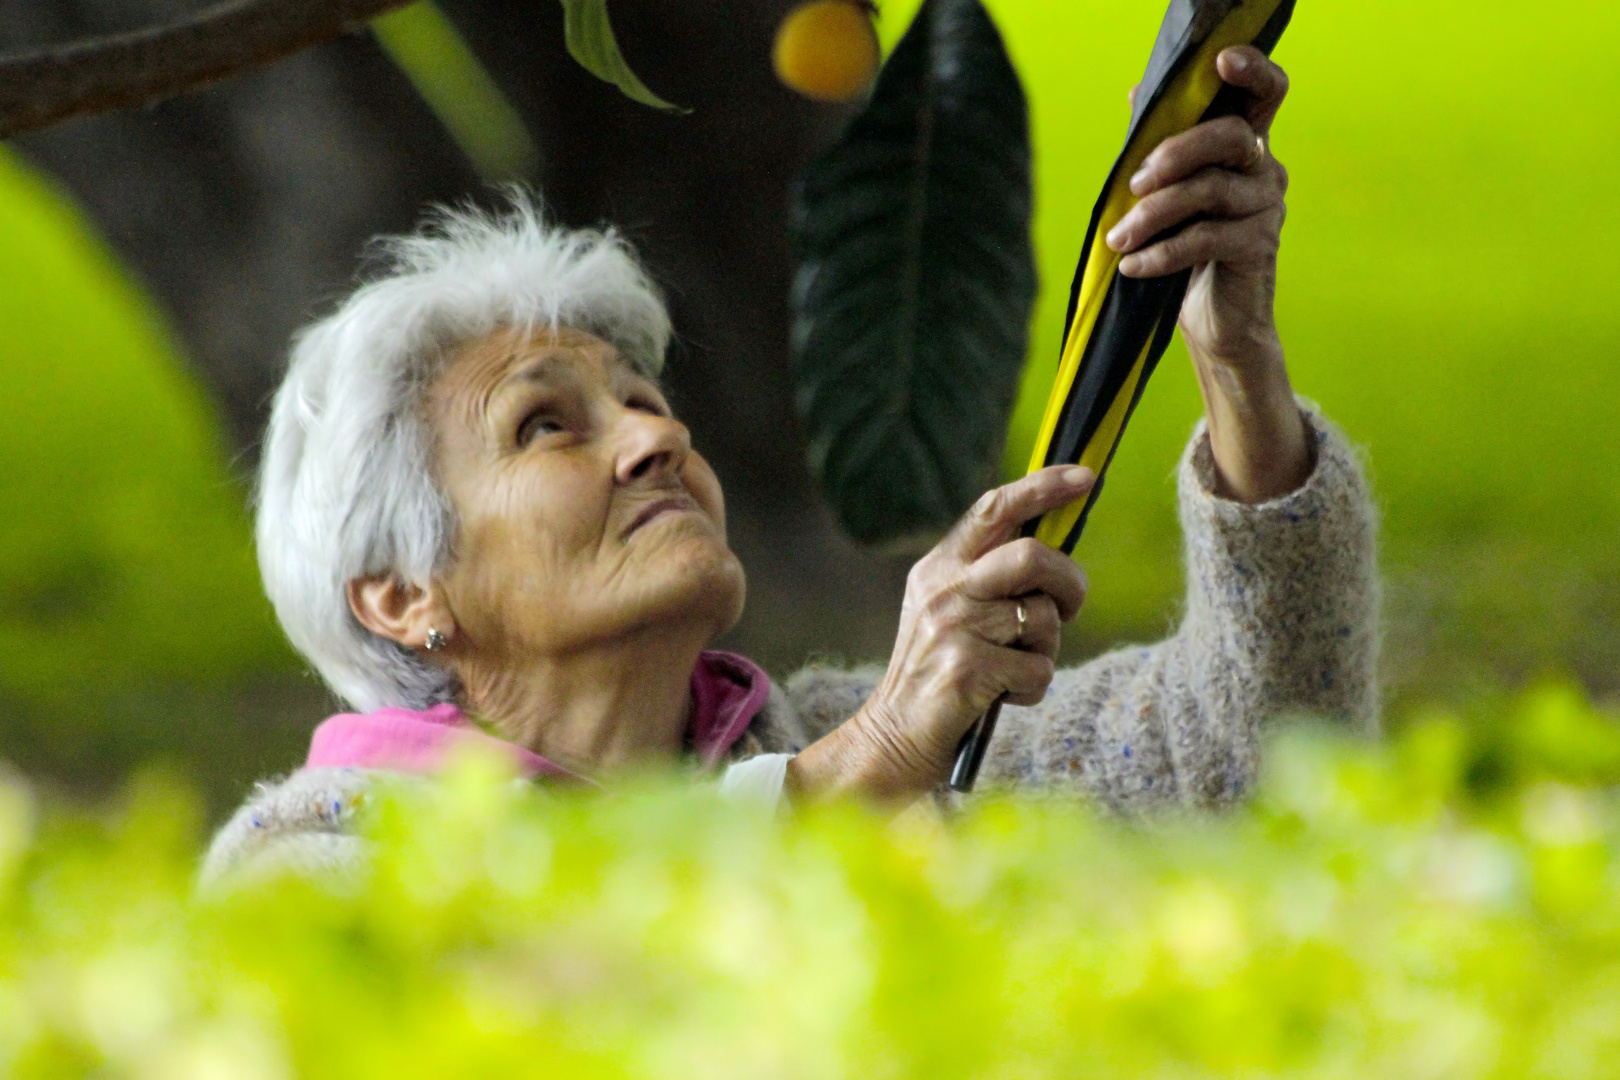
[[256, 189, 669, 711]]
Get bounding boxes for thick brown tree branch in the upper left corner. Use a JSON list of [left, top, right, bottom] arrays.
[[0, 0, 408, 139]]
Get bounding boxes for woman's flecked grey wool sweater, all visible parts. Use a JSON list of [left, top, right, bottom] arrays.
[[203, 408, 1379, 881]]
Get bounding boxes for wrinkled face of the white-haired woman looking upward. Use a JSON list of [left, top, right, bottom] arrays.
[[428, 327, 744, 665]]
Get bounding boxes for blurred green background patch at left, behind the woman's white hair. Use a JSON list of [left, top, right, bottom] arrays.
[[0, 149, 301, 786]]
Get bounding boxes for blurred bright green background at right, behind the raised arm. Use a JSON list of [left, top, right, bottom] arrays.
[[881, 0, 1620, 699]]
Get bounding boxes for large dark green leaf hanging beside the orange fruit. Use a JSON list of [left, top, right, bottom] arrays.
[[792, 0, 1035, 542]]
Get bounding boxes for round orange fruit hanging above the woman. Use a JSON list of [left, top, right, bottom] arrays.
[[771, 0, 881, 102]]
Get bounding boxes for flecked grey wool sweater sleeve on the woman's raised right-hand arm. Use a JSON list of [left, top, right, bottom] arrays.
[[983, 408, 1379, 811]]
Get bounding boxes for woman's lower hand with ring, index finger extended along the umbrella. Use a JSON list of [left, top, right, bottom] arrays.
[[787, 465, 1094, 800]]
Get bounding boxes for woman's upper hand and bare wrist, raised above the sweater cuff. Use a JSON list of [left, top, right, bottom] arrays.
[[1106, 47, 1312, 502]]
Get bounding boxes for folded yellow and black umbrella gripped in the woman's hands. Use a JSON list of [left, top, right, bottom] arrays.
[[951, 0, 1294, 792]]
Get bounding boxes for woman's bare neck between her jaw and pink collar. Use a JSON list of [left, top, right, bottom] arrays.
[[460, 627, 708, 777]]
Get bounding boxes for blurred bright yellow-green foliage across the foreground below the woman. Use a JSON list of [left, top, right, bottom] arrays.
[[0, 687, 1620, 1080]]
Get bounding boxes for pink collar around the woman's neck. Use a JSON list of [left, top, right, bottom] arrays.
[[305, 649, 771, 779]]
